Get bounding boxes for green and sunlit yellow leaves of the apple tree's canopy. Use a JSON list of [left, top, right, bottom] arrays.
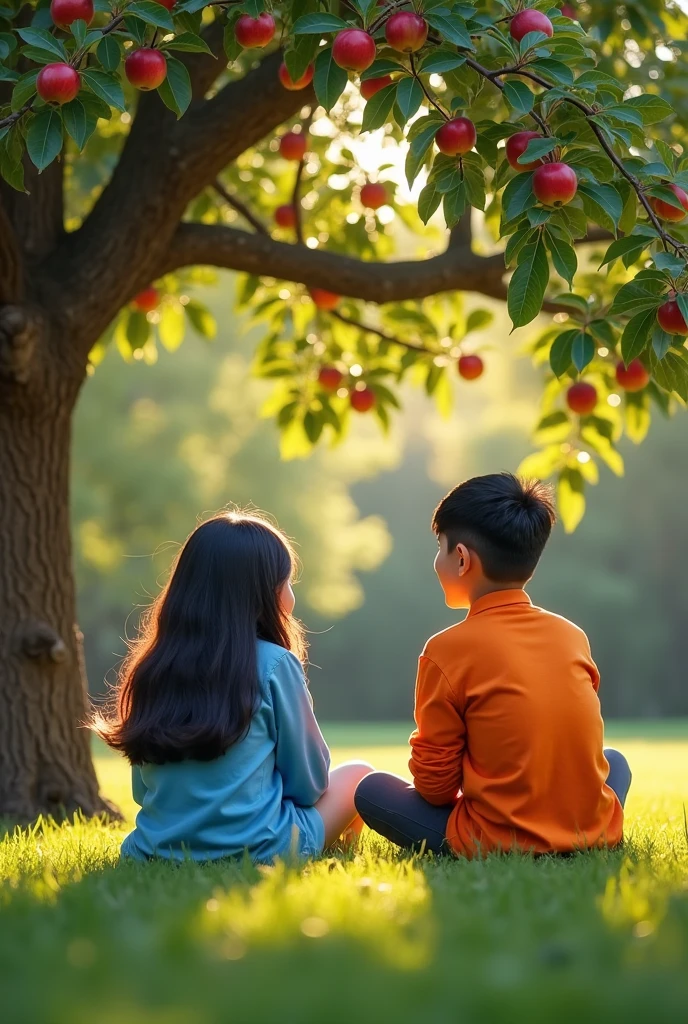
[[0, 0, 688, 528]]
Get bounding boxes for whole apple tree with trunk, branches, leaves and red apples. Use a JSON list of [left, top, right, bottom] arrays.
[[0, 0, 688, 819]]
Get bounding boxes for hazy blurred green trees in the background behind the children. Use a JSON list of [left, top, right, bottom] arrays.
[[74, 274, 688, 721]]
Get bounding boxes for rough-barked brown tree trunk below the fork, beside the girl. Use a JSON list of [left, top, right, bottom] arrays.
[[0, 307, 112, 821]]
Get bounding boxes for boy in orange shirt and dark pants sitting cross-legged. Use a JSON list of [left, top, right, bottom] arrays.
[[355, 473, 631, 857]]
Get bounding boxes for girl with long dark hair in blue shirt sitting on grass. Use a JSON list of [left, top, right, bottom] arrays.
[[95, 512, 372, 862]]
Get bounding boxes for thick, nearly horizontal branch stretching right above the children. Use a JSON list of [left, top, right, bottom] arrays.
[[157, 223, 505, 302]]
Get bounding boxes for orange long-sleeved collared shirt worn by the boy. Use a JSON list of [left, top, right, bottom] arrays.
[[410, 590, 624, 857]]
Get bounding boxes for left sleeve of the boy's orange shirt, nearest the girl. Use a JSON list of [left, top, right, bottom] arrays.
[[409, 655, 466, 806]]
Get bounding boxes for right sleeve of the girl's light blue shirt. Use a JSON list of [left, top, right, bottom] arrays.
[[269, 652, 330, 807]]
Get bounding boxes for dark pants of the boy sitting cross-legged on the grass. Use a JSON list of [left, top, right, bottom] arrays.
[[354, 748, 631, 853]]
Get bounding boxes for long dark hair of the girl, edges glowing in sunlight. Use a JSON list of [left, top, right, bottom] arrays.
[[92, 512, 305, 764]]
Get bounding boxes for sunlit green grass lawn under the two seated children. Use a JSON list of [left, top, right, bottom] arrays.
[[0, 724, 688, 1024]]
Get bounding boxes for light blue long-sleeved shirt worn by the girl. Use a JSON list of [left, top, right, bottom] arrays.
[[122, 640, 330, 862]]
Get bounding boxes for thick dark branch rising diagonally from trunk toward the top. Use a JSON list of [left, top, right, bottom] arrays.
[[45, 53, 313, 358]]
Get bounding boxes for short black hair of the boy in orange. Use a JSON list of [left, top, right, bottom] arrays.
[[432, 473, 556, 583]]
